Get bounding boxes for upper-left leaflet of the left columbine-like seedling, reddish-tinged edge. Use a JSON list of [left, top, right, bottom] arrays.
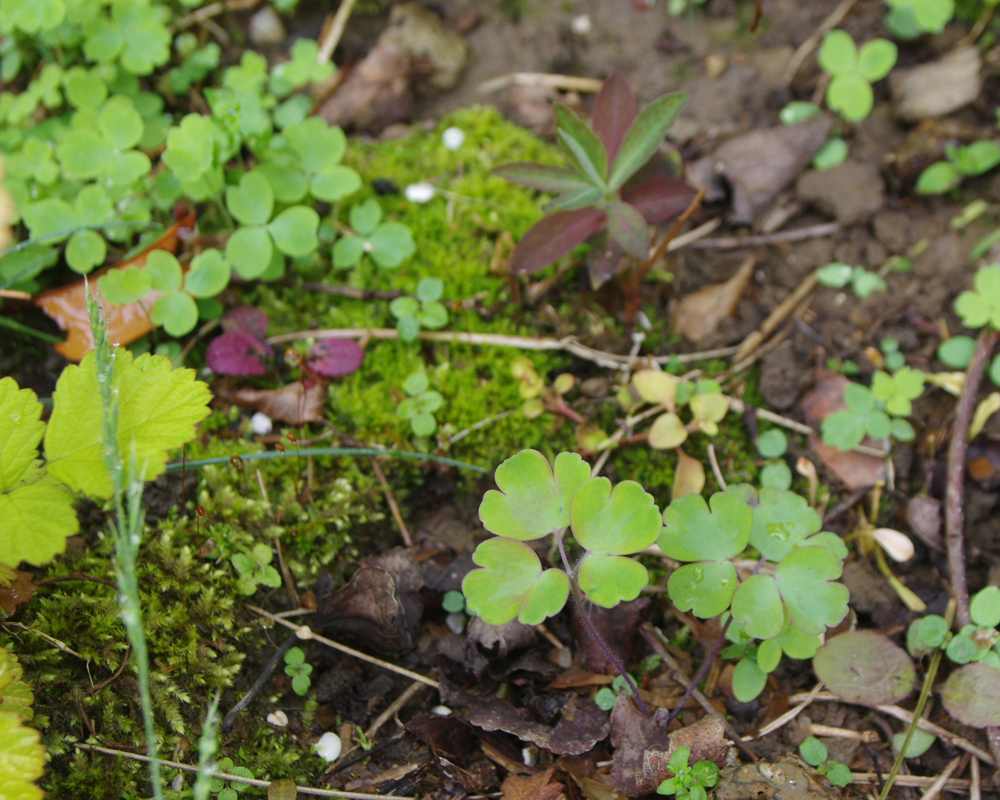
[[478, 446, 590, 541]]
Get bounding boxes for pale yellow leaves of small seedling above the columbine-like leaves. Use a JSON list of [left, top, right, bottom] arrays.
[[632, 369, 729, 450]]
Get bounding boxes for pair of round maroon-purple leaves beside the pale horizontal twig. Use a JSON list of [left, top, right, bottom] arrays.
[[205, 306, 365, 378]]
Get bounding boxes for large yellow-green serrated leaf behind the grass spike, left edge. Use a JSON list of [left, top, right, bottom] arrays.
[[0, 348, 211, 566]]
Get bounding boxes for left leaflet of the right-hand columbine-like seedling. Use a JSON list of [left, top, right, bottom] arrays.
[[660, 492, 753, 619]]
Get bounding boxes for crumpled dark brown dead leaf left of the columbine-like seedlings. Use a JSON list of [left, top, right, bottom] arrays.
[[313, 547, 424, 655]]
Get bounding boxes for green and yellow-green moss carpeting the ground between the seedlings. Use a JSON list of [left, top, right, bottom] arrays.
[[0, 109, 757, 800]]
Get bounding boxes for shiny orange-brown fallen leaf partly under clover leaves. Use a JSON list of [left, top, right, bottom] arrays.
[[32, 212, 195, 362]]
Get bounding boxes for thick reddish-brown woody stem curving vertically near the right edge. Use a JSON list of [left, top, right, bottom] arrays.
[[945, 327, 1000, 776]]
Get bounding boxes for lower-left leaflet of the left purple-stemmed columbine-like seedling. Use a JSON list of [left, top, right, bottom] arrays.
[[462, 536, 569, 625]]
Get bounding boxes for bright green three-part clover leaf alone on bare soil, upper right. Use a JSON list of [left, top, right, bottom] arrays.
[[817, 30, 898, 122]]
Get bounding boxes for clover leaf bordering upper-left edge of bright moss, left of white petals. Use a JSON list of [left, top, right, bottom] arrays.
[[258, 119, 361, 208]]
